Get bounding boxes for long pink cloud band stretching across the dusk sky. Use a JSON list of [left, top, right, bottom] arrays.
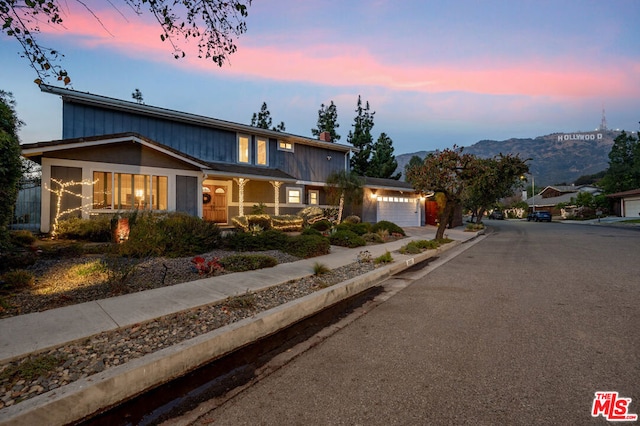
[[43, 10, 640, 98]]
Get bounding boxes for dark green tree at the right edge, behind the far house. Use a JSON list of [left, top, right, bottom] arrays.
[[600, 132, 640, 193]]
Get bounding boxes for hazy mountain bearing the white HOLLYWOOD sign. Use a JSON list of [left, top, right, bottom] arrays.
[[396, 130, 620, 186]]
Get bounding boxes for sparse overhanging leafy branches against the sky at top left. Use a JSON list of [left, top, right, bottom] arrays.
[[0, 0, 251, 85]]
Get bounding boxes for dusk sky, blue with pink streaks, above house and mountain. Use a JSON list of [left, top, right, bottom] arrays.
[[0, 0, 640, 155]]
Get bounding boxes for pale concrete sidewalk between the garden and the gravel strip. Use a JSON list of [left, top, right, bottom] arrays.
[[0, 226, 470, 362]]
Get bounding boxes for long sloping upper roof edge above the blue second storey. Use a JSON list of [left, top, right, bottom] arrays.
[[40, 84, 359, 152]]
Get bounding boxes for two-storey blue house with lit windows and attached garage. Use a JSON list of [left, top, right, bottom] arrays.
[[22, 85, 421, 232]]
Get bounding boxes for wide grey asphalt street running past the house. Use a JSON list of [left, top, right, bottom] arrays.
[[186, 221, 640, 425]]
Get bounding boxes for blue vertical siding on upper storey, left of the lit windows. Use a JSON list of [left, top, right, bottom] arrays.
[[62, 102, 238, 163]]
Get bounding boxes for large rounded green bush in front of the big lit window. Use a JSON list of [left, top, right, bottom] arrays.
[[120, 212, 221, 257]]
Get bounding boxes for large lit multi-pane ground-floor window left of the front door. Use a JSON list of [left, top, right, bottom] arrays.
[[92, 171, 169, 210]]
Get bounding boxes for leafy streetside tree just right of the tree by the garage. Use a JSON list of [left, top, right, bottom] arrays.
[[464, 154, 529, 223]]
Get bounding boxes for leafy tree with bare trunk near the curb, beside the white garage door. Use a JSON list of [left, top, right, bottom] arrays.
[[406, 146, 477, 238]]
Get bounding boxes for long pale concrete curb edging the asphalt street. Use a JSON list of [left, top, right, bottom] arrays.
[[0, 241, 460, 426]]
